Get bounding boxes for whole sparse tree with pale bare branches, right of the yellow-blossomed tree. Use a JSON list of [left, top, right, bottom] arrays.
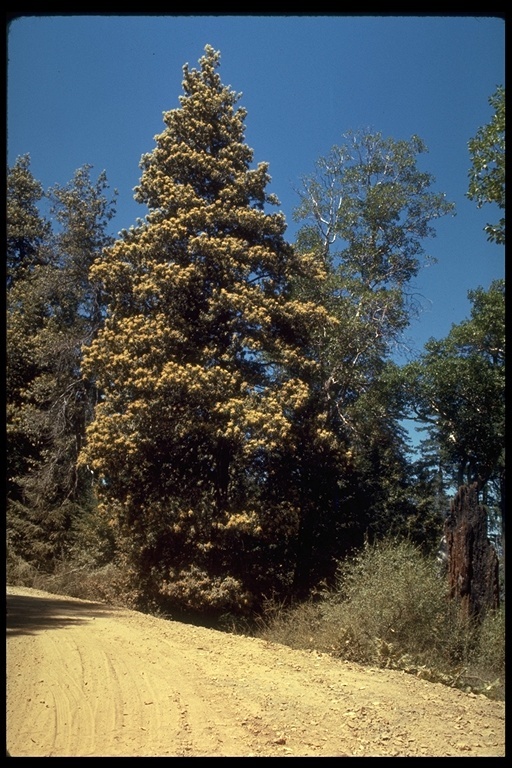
[[295, 132, 453, 559]]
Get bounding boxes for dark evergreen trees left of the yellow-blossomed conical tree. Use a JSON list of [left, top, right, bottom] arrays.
[[7, 158, 113, 570]]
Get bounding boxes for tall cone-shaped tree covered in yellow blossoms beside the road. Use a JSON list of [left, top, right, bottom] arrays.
[[82, 46, 336, 610]]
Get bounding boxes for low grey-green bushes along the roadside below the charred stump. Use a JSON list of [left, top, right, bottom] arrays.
[[256, 539, 505, 698]]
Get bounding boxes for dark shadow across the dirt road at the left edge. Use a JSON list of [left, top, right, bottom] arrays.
[[5, 595, 116, 637]]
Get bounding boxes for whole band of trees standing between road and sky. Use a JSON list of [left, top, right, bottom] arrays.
[[6, 46, 505, 614]]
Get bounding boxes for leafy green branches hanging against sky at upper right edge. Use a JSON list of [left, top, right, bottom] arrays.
[[467, 86, 505, 245]]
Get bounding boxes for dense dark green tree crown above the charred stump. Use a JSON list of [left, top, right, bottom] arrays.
[[399, 280, 505, 516]]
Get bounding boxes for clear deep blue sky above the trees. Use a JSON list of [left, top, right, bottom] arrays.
[[7, 14, 505, 360]]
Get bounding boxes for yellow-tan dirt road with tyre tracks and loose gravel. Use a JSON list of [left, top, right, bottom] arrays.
[[7, 587, 505, 757]]
